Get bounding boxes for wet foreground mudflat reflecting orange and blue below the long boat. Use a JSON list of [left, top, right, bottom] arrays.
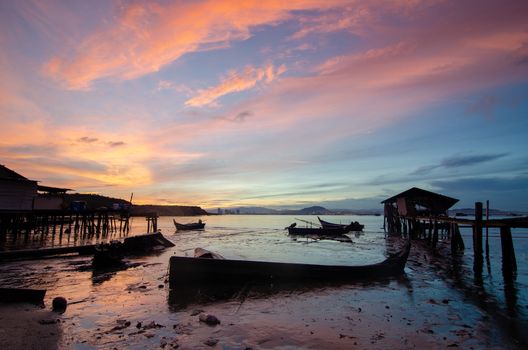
[[0, 241, 524, 349]]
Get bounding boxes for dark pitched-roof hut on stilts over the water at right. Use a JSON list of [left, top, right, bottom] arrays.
[[381, 187, 458, 238]]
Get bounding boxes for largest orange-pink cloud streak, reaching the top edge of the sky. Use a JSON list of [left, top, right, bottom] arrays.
[[44, 0, 340, 89]]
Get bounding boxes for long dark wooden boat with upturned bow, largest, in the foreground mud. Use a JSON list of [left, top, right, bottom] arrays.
[[169, 241, 411, 288]]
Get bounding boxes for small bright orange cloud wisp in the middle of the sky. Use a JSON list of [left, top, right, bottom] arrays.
[[185, 64, 286, 107]]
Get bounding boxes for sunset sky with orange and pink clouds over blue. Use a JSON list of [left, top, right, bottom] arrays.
[[0, 0, 528, 211]]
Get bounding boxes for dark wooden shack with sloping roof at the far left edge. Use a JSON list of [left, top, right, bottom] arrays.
[[0, 164, 38, 210]]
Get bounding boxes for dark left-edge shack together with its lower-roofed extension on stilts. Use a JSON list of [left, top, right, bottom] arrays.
[[0, 164, 70, 210]]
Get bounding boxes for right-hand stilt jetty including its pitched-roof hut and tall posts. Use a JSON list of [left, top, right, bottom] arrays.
[[382, 187, 528, 282]]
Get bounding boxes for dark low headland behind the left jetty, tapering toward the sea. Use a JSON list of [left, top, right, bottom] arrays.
[[64, 193, 207, 216]]
